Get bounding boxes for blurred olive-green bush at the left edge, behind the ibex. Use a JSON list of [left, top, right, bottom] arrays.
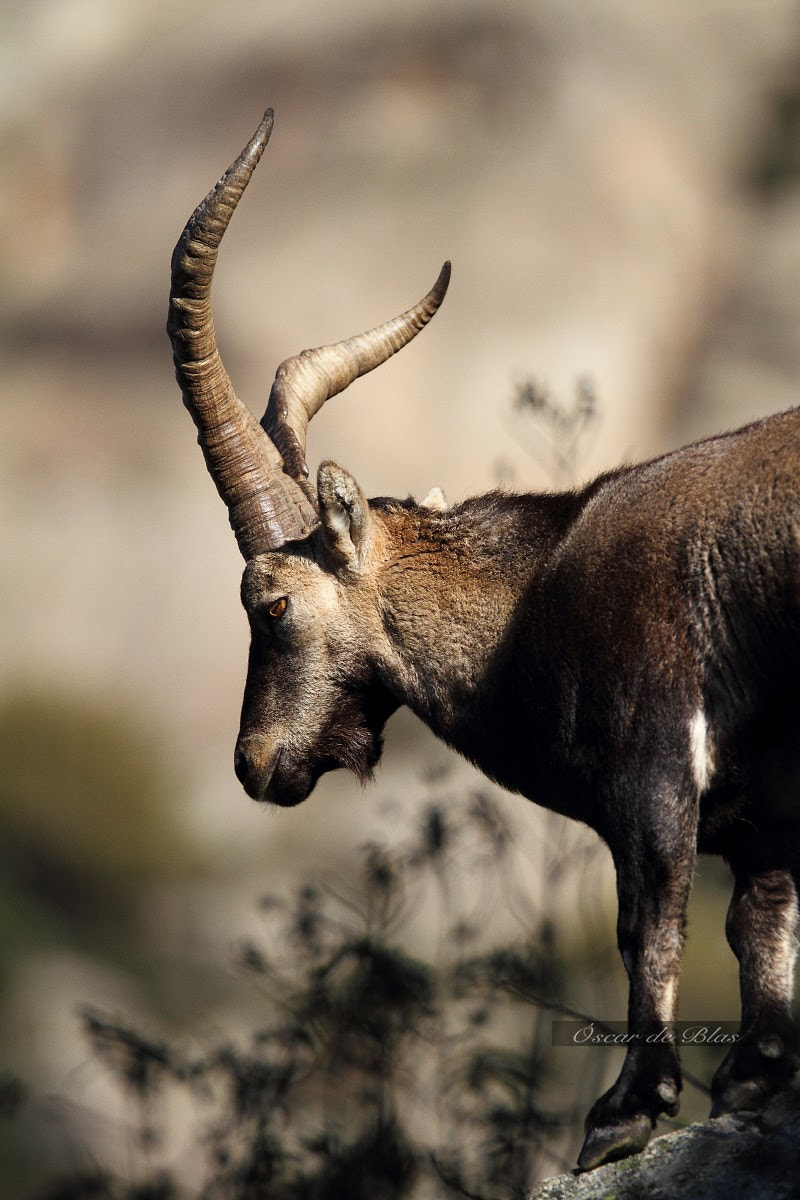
[[0, 691, 186, 989]]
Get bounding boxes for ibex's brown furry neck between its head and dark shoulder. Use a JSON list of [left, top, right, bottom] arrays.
[[381, 493, 583, 786]]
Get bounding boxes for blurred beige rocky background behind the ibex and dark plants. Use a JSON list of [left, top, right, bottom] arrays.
[[0, 0, 800, 1196]]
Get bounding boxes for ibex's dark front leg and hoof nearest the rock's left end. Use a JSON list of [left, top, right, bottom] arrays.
[[578, 792, 697, 1170]]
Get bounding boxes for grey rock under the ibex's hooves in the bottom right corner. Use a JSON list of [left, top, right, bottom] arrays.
[[529, 1085, 800, 1200]]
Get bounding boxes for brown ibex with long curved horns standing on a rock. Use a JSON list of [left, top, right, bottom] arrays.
[[168, 112, 800, 1169]]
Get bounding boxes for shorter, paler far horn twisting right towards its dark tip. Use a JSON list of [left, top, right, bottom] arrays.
[[261, 262, 450, 484]]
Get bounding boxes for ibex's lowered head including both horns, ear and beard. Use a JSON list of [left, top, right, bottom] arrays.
[[167, 110, 450, 805]]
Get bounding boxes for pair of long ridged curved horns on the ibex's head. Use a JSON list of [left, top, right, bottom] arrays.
[[167, 109, 450, 559]]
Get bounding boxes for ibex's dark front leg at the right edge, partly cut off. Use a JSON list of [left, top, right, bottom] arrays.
[[711, 846, 800, 1116]]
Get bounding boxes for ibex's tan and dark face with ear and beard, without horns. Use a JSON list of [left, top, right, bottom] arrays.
[[235, 463, 397, 806]]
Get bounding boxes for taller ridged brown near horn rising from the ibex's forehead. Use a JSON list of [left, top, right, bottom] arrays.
[[167, 109, 318, 559]]
